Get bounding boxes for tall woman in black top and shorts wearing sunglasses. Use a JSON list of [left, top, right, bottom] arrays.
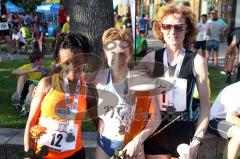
[[141, 4, 210, 159]]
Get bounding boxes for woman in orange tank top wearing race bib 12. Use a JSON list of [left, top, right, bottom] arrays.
[[24, 33, 90, 159]]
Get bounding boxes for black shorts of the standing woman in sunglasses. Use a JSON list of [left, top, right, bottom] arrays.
[[144, 120, 195, 157]]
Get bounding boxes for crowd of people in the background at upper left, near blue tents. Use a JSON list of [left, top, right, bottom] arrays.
[[0, 2, 70, 54]]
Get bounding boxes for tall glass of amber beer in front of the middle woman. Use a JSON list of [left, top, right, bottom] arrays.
[[123, 76, 172, 147]]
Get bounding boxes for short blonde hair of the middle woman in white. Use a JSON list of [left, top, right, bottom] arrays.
[[102, 28, 133, 50]]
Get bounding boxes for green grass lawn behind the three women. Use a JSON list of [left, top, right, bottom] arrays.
[[0, 59, 235, 131]]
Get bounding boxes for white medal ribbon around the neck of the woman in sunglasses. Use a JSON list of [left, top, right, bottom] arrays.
[[163, 49, 185, 104]]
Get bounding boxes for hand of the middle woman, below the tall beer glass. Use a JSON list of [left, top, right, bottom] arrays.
[[120, 137, 142, 159]]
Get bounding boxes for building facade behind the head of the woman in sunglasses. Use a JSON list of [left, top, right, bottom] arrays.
[[136, 0, 240, 23]]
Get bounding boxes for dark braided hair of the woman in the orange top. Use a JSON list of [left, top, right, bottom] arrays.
[[50, 32, 91, 62]]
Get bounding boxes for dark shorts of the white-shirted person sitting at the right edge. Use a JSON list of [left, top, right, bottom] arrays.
[[208, 118, 233, 139]]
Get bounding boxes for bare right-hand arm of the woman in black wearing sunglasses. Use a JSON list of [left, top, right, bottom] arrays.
[[193, 55, 210, 138]]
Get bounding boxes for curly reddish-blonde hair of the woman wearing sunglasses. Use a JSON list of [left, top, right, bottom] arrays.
[[153, 3, 198, 44]]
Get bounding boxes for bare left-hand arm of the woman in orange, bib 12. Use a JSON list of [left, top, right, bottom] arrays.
[[24, 77, 50, 151]]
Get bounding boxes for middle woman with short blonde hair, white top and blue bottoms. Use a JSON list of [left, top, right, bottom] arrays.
[[94, 28, 160, 159]]
